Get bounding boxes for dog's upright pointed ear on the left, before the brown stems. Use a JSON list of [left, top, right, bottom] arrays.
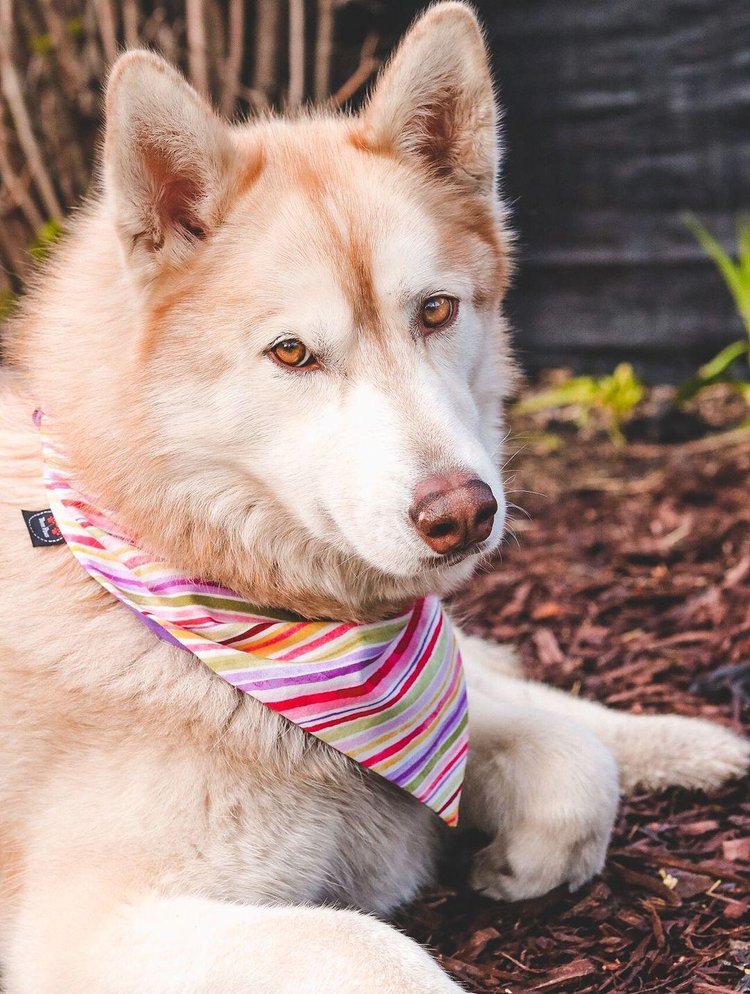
[[104, 51, 233, 274]]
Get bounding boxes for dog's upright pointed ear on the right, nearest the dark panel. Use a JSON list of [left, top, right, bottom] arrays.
[[363, 2, 498, 197]]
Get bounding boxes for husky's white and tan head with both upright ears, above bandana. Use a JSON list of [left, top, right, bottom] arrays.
[[97, 4, 509, 612]]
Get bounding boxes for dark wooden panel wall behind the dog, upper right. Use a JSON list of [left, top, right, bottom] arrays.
[[370, 0, 750, 376]]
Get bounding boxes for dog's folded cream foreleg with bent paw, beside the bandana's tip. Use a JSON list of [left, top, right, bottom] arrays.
[[461, 688, 618, 901]]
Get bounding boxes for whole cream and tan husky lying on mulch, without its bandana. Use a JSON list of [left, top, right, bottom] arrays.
[[0, 3, 748, 994]]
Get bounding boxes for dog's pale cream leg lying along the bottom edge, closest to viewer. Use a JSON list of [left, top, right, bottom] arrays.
[[4, 881, 462, 994]]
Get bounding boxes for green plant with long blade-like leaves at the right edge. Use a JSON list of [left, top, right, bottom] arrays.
[[677, 214, 750, 403]]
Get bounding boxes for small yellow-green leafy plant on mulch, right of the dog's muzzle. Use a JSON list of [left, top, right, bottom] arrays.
[[516, 362, 644, 444]]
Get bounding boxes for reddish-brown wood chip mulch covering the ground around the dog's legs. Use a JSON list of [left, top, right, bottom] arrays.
[[399, 416, 750, 994]]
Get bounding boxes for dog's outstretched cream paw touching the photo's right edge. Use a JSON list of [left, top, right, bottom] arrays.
[[611, 715, 750, 791]]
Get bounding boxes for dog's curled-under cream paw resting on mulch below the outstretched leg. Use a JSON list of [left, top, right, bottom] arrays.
[[470, 730, 618, 901]]
